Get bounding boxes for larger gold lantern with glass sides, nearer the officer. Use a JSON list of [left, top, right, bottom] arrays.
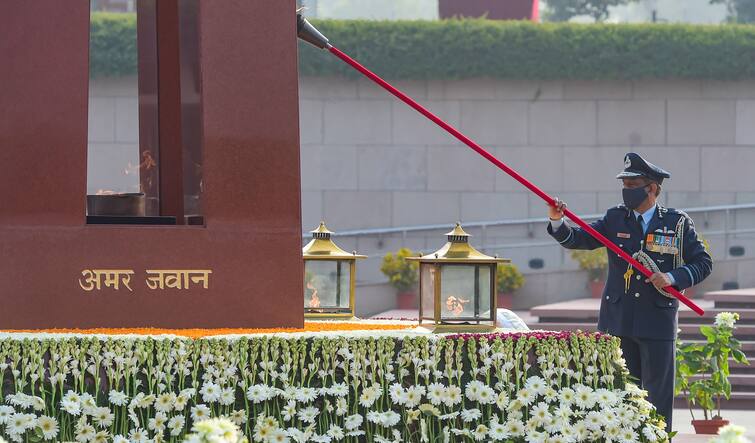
[[407, 223, 511, 332]]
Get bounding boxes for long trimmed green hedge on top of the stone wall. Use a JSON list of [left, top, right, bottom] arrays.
[[92, 14, 755, 80]]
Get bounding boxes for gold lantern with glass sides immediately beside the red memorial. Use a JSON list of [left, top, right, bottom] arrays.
[[302, 222, 367, 318]]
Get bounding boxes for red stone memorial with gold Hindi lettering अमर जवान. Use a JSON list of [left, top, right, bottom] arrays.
[[0, 0, 303, 328]]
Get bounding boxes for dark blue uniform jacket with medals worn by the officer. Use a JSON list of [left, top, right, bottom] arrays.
[[547, 205, 713, 340]]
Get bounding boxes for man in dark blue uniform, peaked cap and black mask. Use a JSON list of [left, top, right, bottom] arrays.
[[548, 152, 713, 431]]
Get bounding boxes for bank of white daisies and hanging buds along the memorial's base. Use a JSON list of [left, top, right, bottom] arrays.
[[0, 331, 668, 443]]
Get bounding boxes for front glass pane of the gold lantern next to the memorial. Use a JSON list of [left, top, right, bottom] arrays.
[[304, 260, 351, 309]]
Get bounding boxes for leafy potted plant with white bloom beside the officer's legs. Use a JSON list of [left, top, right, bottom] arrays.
[[675, 312, 749, 434]]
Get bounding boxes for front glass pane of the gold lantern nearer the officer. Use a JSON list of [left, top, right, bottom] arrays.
[[440, 265, 491, 321]]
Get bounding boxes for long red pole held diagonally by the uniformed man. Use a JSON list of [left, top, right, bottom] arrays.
[[327, 45, 705, 315]]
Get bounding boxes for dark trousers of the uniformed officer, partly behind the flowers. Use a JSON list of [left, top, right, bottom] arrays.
[[620, 337, 676, 432]]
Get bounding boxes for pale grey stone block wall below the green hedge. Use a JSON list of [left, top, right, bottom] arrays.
[[89, 78, 755, 307]]
